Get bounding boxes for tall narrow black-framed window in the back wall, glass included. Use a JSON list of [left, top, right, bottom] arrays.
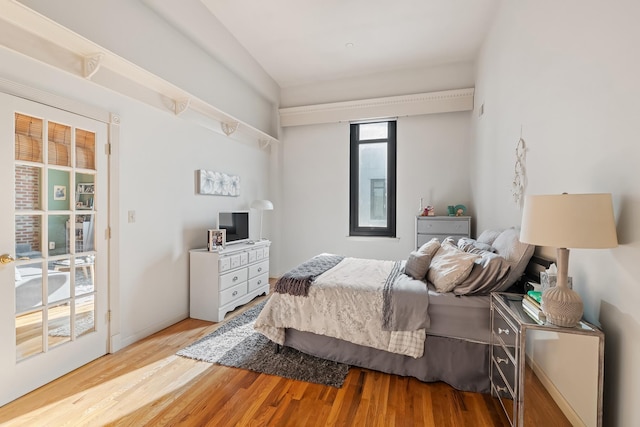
[[349, 121, 396, 237]]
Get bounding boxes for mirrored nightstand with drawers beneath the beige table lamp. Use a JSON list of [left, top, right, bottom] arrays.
[[489, 292, 604, 426]]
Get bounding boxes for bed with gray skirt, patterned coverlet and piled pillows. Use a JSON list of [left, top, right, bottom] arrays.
[[254, 228, 534, 393]]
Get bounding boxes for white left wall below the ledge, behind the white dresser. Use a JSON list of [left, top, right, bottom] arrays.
[[0, 43, 270, 346]]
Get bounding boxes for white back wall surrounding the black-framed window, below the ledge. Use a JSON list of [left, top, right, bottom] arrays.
[[277, 112, 473, 273]]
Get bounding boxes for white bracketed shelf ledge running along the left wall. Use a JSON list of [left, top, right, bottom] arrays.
[[0, 0, 278, 148]]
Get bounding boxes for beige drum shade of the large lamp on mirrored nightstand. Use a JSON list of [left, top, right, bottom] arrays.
[[520, 194, 618, 249]]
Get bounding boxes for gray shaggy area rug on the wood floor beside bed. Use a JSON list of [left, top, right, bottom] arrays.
[[177, 302, 349, 388]]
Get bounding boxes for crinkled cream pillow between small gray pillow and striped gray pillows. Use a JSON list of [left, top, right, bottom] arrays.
[[427, 241, 480, 292]]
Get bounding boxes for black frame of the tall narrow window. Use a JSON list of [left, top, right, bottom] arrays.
[[349, 120, 397, 237]]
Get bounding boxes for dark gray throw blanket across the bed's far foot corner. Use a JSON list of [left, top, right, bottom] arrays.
[[275, 255, 344, 297]]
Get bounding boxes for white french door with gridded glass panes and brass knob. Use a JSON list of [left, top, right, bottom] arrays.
[[0, 93, 108, 405]]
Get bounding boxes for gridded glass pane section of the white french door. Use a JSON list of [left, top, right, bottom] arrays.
[[15, 113, 96, 361]]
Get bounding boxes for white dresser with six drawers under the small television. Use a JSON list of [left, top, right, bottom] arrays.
[[189, 240, 271, 322]]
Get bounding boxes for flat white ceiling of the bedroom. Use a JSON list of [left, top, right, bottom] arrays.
[[143, 0, 500, 88]]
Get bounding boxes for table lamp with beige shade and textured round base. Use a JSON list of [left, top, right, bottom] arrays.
[[520, 193, 618, 327]]
